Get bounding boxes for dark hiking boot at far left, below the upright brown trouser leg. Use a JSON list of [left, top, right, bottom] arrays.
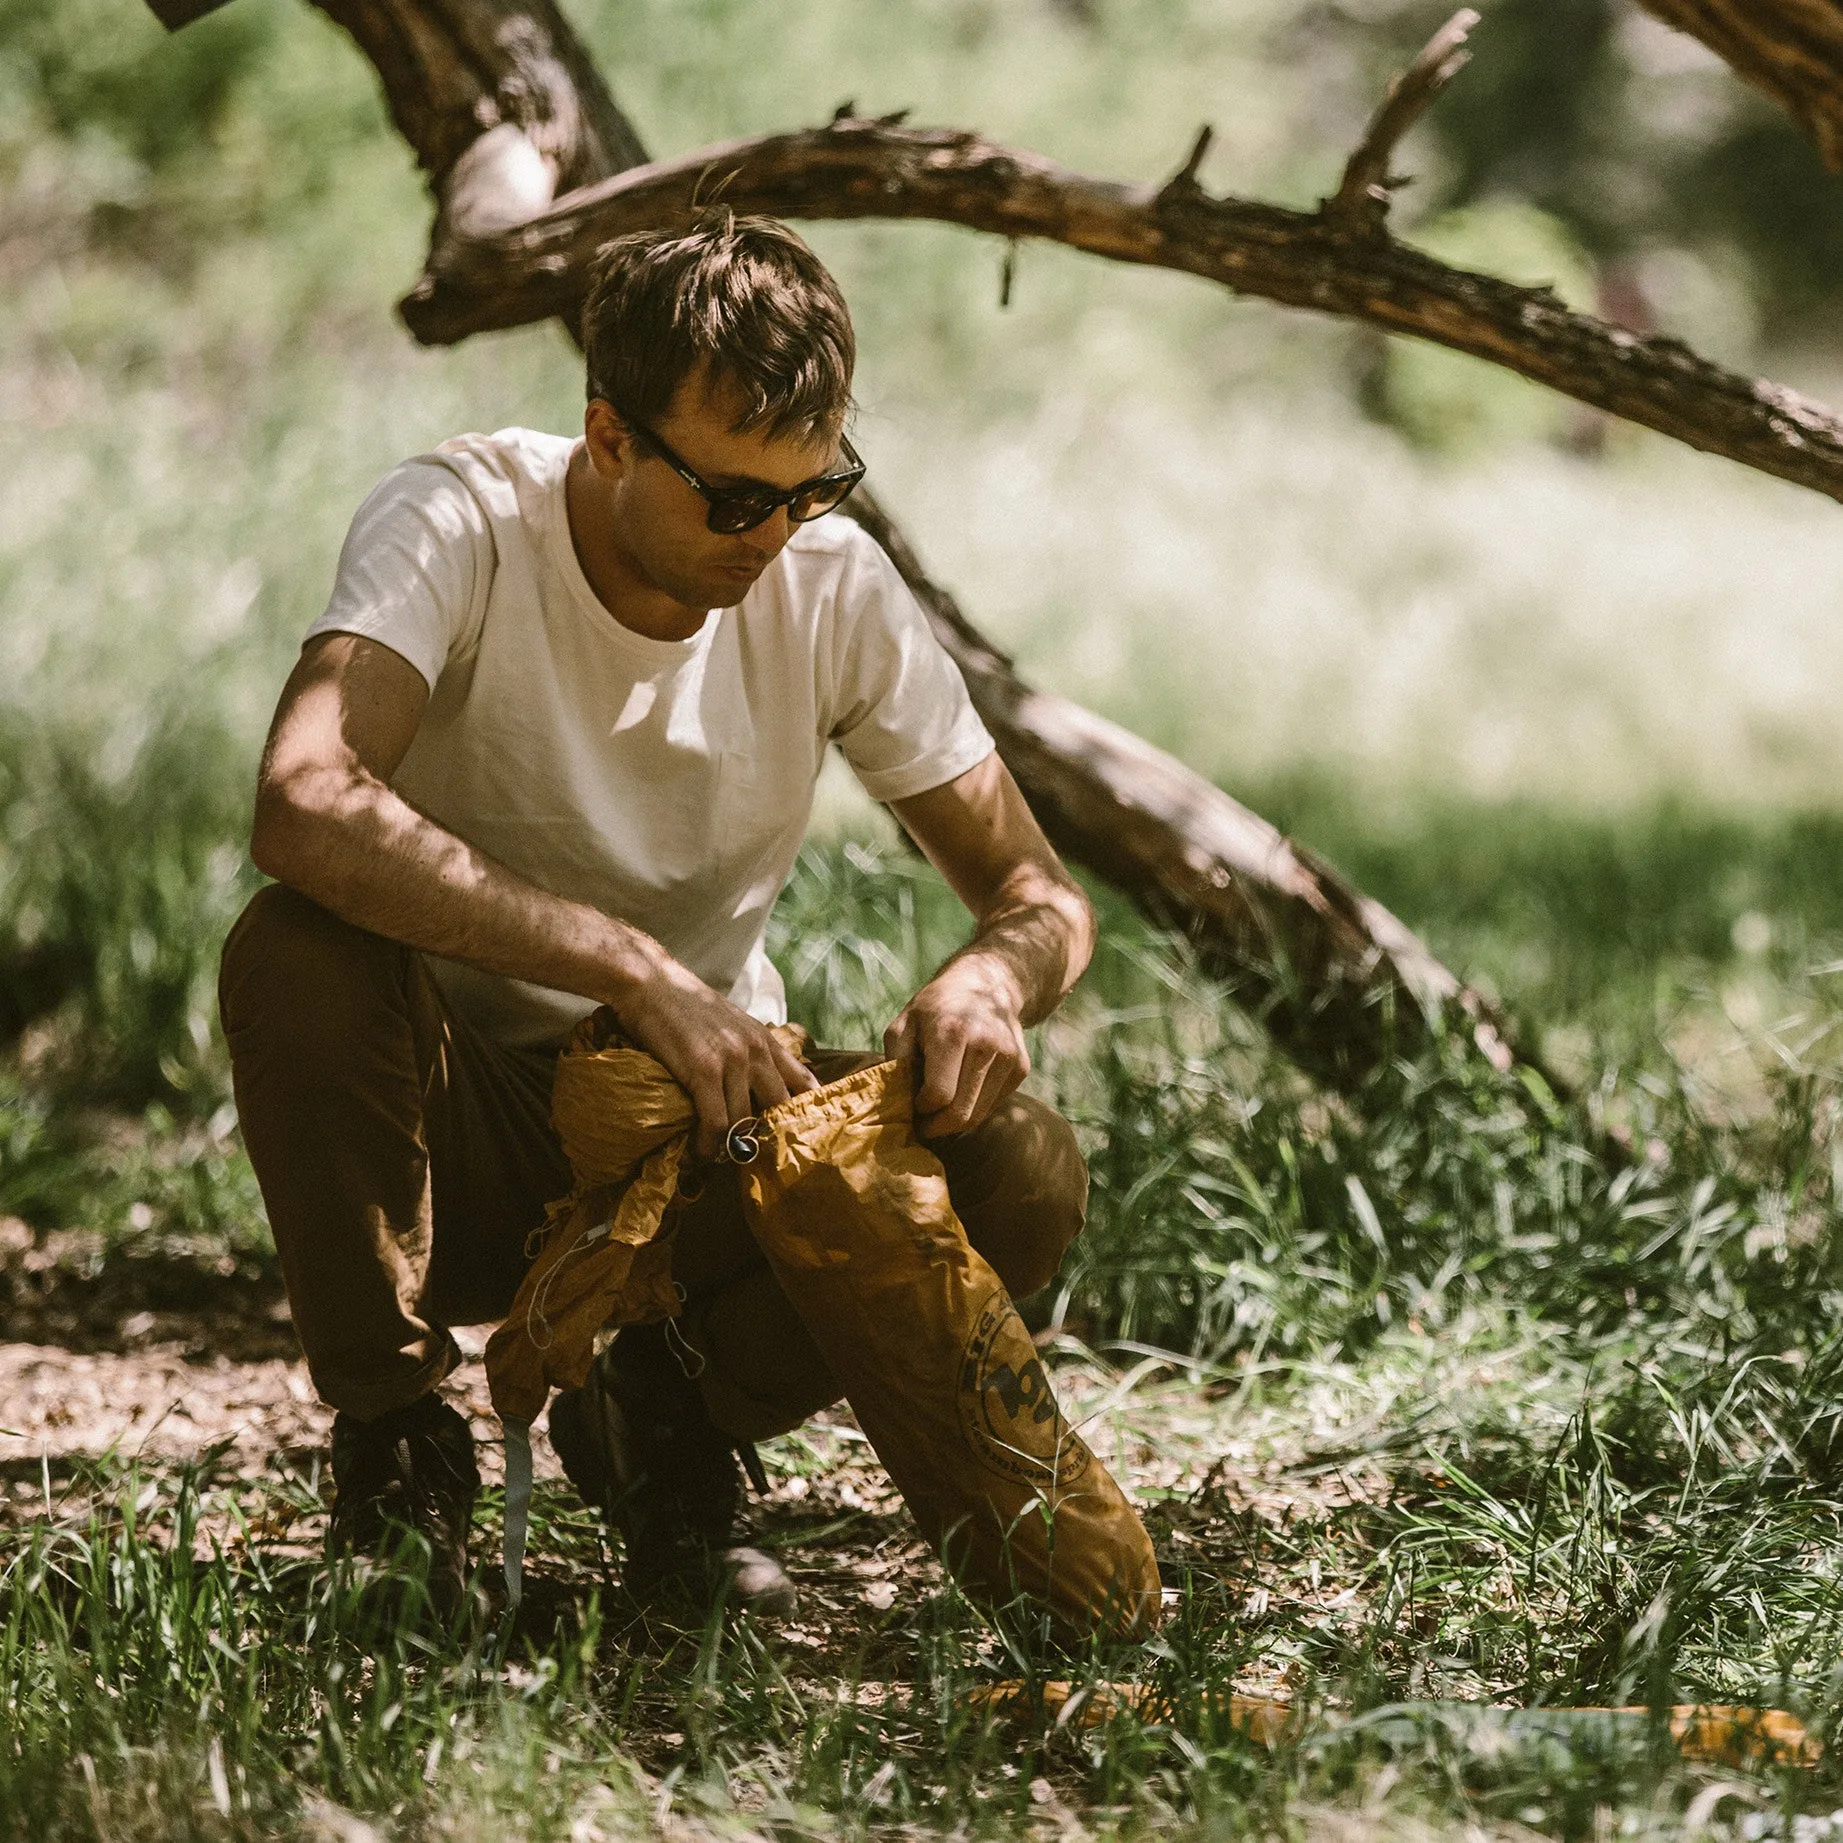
[[326, 1395, 479, 1618]]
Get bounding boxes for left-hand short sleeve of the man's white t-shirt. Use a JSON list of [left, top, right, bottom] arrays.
[[306, 461, 494, 691]]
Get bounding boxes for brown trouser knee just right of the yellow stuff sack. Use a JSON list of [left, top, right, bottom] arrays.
[[936, 1095, 1087, 1299]]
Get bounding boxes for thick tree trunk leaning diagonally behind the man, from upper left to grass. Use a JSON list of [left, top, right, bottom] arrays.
[[162, 0, 1540, 1091]]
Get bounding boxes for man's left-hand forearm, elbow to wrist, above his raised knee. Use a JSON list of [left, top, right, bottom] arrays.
[[251, 769, 671, 1008]]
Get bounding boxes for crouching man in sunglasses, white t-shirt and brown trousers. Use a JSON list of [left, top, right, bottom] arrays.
[[219, 214, 1093, 1605]]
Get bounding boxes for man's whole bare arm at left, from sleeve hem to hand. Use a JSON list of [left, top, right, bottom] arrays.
[[251, 634, 813, 1150]]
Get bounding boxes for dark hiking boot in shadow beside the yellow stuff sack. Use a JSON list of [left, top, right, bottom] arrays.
[[549, 1325, 796, 1618]]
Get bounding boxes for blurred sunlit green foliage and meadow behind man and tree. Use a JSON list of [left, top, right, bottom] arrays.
[[0, 0, 1843, 1297]]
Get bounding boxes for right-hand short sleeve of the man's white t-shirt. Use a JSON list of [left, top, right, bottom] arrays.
[[831, 531, 993, 800]]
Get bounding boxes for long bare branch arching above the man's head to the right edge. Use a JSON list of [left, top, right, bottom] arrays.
[[402, 118, 1843, 499]]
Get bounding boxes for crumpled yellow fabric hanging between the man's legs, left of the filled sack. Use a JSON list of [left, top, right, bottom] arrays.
[[487, 1010, 807, 1421]]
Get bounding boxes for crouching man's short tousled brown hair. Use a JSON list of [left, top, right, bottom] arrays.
[[582, 210, 857, 440]]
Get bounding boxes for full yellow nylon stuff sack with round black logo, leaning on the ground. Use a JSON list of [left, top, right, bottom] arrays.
[[741, 1062, 1159, 1635]]
